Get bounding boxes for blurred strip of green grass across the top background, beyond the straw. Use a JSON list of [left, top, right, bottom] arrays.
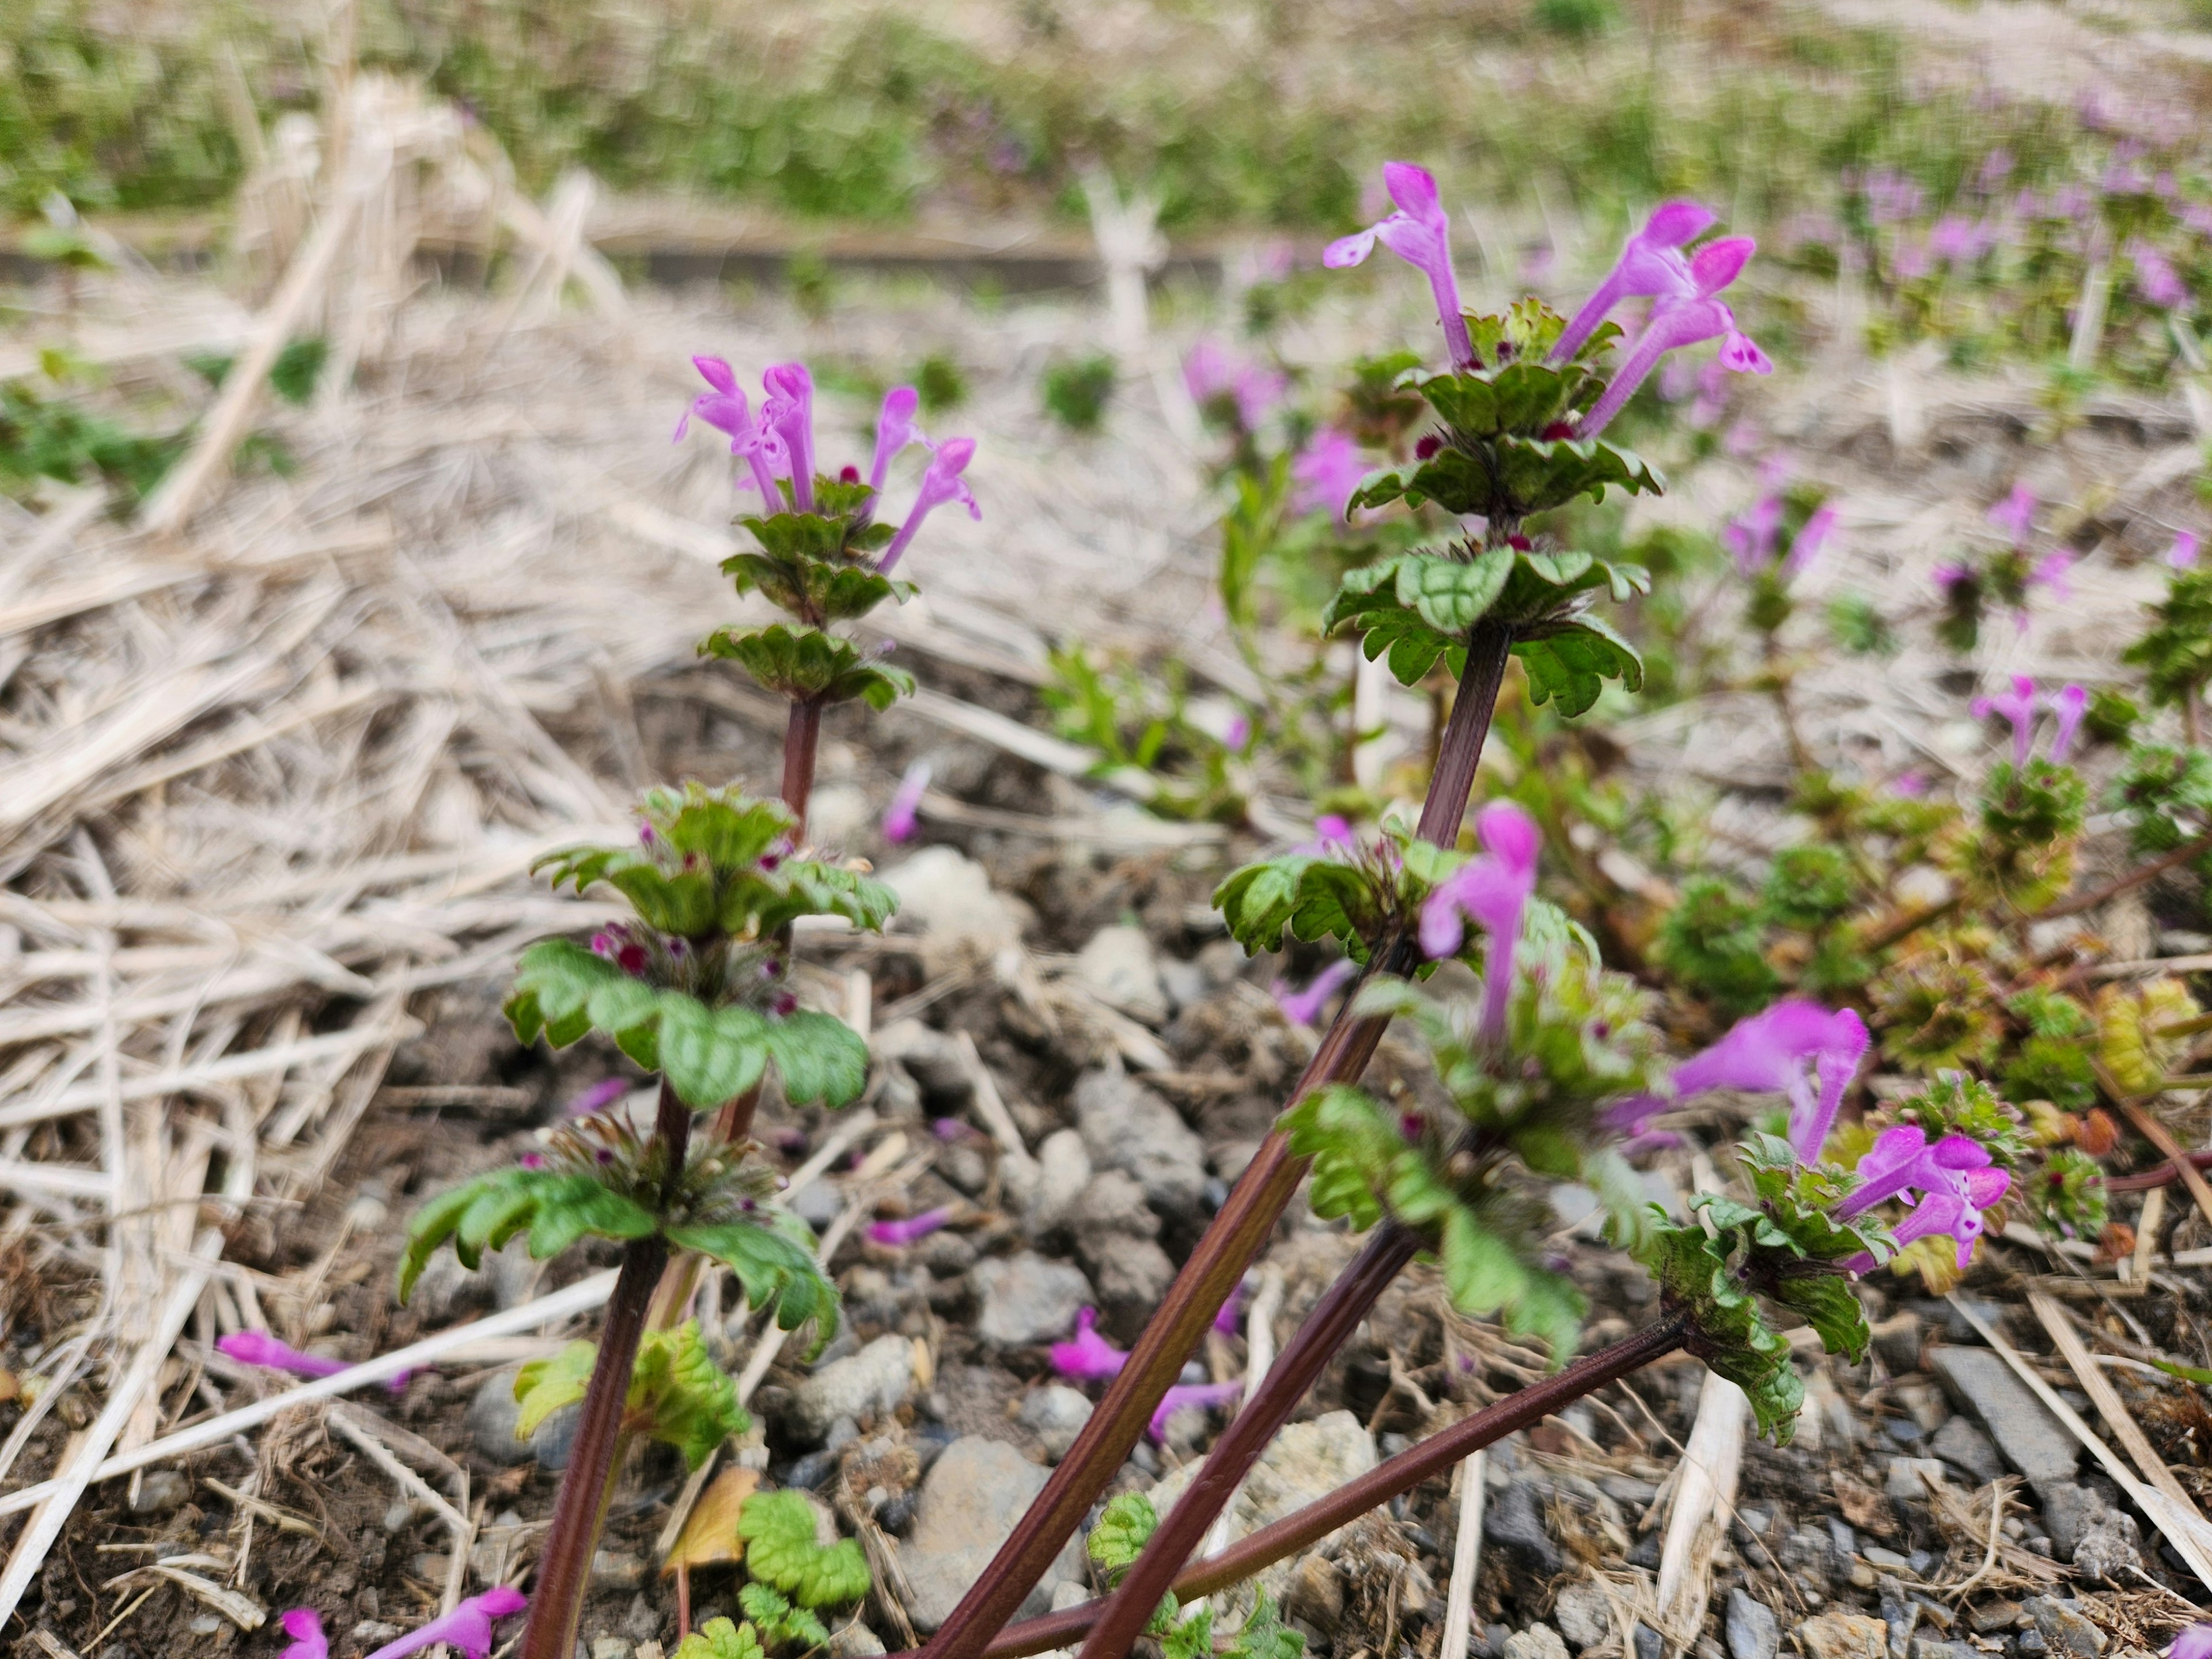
[[0, 0, 2141, 228]]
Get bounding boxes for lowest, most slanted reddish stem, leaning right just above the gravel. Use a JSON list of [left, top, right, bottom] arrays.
[[915, 1314, 1690, 1659]]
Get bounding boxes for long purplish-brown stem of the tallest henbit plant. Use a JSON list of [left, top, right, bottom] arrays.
[[907, 626, 1513, 1659]]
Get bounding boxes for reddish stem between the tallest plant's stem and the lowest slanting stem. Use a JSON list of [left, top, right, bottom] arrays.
[[1080, 1219, 1420, 1659]]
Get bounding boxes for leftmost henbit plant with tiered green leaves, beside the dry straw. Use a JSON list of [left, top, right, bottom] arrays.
[[398, 356, 975, 1659]]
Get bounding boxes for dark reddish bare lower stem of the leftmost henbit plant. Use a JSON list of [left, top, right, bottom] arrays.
[[520, 1077, 690, 1659]]
